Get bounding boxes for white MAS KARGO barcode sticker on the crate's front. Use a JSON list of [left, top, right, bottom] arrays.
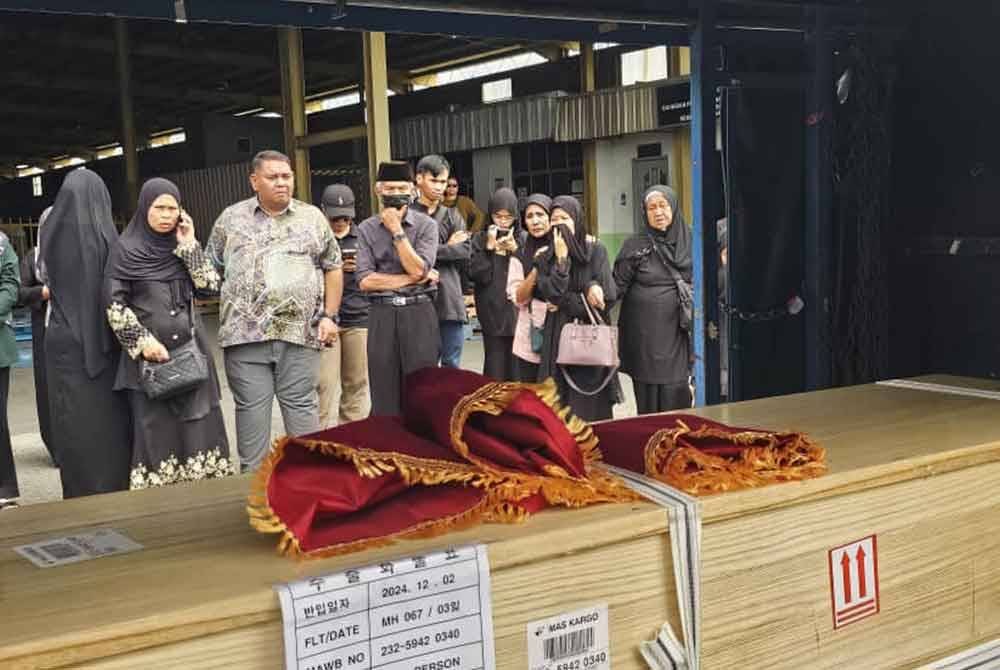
[[527, 604, 611, 670]]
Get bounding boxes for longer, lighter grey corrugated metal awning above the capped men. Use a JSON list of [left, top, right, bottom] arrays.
[[390, 94, 561, 157]]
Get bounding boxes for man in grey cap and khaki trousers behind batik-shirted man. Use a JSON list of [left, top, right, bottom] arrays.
[[316, 184, 371, 429]]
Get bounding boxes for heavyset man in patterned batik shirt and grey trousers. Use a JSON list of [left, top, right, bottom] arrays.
[[207, 151, 343, 472]]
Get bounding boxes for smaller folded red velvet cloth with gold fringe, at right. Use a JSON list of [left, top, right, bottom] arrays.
[[593, 414, 826, 495]]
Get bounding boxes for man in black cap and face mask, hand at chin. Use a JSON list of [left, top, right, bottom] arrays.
[[355, 162, 440, 416]]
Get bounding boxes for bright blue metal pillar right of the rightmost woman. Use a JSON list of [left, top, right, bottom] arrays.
[[691, 0, 721, 406]]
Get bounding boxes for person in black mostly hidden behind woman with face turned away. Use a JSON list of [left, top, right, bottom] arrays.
[[17, 207, 59, 464]]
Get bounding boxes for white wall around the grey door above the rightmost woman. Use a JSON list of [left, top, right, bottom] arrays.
[[597, 131, 675, 242]]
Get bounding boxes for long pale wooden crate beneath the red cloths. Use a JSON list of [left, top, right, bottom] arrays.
[[0, 378, 1000, 670]]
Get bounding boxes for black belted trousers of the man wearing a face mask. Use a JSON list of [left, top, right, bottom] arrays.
[[368, 302, 441, 416]]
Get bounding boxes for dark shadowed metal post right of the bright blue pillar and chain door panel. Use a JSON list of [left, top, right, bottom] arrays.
[[805, 6, 833, 391]]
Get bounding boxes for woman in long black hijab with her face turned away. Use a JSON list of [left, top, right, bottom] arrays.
[[39, 168, 131, 498]]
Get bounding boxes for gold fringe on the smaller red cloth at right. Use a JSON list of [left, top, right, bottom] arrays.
[[644, 420, 827, 496]]
